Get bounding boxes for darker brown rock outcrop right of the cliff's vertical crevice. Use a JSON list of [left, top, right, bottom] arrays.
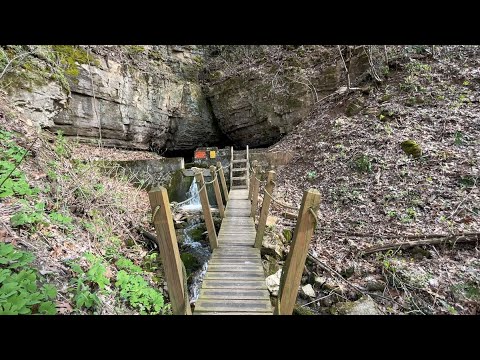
[[207, 46, 368, 147]]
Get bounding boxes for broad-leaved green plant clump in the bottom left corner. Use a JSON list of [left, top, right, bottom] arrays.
[[0, 243, 57, 315]]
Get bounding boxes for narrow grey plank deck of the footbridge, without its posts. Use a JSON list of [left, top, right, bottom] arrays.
[[194, 150, 273, 315]]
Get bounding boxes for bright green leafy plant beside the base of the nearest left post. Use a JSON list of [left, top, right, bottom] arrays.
[[115, 258, 168, 314]]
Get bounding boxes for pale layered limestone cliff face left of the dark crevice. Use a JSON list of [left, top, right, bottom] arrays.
[[9, 46, 220, 150]]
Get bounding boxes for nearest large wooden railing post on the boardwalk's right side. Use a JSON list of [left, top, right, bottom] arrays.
[[274, 189, 320, 315]]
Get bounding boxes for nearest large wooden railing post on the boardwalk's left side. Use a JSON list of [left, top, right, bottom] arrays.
[[148, 187, 192, 315]]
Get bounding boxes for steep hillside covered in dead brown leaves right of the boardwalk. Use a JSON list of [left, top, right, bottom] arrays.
[[269, 47, 480, 314]]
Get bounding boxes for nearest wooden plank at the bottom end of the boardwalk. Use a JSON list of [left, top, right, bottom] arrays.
[[195, 299, 273, 312]]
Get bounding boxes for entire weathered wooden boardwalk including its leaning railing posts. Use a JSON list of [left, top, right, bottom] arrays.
[[149, 146, 320, 315]]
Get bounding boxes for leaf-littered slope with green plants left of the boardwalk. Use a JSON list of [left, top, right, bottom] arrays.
[[0, 97, 171, 314]]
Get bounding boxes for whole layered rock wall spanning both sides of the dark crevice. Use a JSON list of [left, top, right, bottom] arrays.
[[3, 45, 368, 152]]
